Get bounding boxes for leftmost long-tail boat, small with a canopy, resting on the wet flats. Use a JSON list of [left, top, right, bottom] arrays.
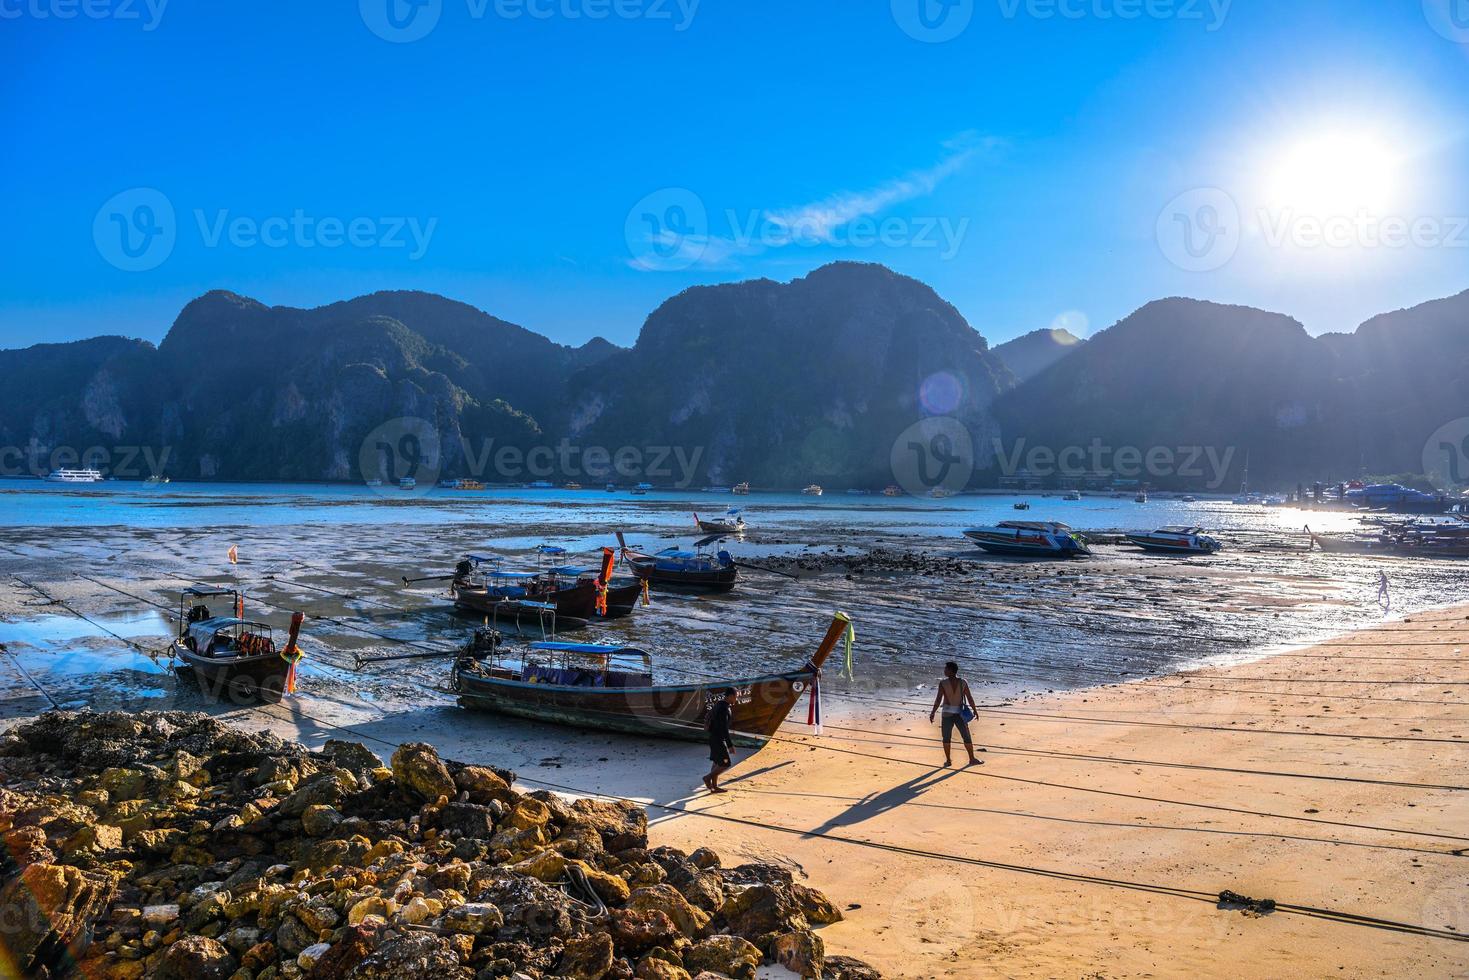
[[173, 585, 306, 704]]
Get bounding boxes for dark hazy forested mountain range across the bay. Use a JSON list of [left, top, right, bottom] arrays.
[[0, 263, 1469, 489]]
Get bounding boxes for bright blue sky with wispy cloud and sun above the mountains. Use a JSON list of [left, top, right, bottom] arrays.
[[0, 0, 1469, 347]]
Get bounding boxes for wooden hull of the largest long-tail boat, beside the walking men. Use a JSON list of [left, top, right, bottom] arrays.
[[451, 614, 851, 746]]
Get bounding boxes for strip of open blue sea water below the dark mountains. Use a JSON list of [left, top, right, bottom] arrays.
[[0, 479, 1353, 536]]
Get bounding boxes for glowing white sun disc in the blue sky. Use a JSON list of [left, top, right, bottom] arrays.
[[1271, 131, 1400, 217]]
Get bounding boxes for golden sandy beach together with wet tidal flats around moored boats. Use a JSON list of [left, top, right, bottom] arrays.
[[0, 517, 1469, 977]]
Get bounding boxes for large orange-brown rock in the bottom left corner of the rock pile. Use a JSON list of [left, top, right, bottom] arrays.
[[0, 864, 116, 974]]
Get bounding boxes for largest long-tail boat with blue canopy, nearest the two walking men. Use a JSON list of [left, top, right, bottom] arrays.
[[451, 613, 851, 746]]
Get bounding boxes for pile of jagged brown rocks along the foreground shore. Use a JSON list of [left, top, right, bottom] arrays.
[[0, 711, 878, 980]]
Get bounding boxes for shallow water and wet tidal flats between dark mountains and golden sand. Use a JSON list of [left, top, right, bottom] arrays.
[[0, 480, 1466, 725]]
